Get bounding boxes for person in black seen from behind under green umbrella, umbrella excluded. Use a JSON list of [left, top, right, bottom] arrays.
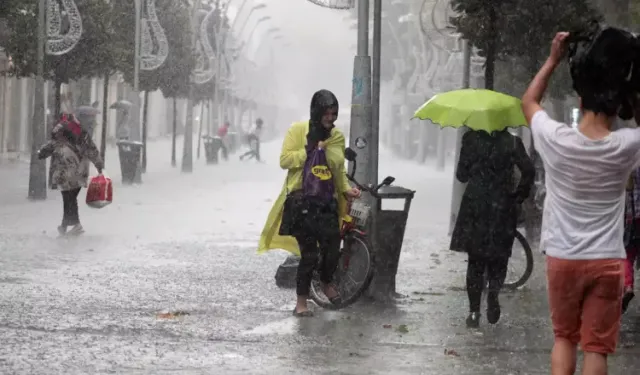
[[450, 130, 535, 328]]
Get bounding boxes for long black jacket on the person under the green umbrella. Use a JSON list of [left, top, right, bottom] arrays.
[[450, 131, 535, 257]]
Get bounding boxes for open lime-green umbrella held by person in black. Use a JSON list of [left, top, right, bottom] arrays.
[[414, 89, 527, 133]]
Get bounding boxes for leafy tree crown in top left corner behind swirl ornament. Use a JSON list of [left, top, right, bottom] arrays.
[[4, 0, 120, 83]]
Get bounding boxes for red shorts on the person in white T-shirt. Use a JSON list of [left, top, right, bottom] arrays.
[[547, 256, 624, 354]]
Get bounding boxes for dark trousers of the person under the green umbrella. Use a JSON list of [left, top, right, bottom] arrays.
[[467, 254, 509, 312]]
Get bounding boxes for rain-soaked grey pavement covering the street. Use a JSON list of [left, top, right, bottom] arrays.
[[0, 142, 640, 375]]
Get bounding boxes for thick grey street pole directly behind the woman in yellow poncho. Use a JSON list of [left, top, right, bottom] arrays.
[[349, 0, 376, 187]]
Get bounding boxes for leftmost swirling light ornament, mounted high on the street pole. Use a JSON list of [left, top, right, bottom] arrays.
[[45, 0, 82, 56]]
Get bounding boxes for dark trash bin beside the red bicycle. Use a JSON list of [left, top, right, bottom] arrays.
[[369, 185, 415, 299]]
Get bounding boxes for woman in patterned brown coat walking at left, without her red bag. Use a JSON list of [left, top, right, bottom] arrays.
[[38, 114, 103, 236]]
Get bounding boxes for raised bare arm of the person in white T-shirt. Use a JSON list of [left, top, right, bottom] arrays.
[[522, 32, 569, 124]]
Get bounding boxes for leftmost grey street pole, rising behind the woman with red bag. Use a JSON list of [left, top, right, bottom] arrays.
[[28, 0, 47, 200]]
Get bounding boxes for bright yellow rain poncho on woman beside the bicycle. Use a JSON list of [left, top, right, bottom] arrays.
[[258, 121, 351, 255]]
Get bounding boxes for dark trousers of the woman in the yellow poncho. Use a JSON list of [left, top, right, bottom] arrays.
[[295, 207, 341, 296]]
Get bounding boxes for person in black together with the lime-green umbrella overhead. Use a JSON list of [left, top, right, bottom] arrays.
[[415, 89, 535, 328]]
